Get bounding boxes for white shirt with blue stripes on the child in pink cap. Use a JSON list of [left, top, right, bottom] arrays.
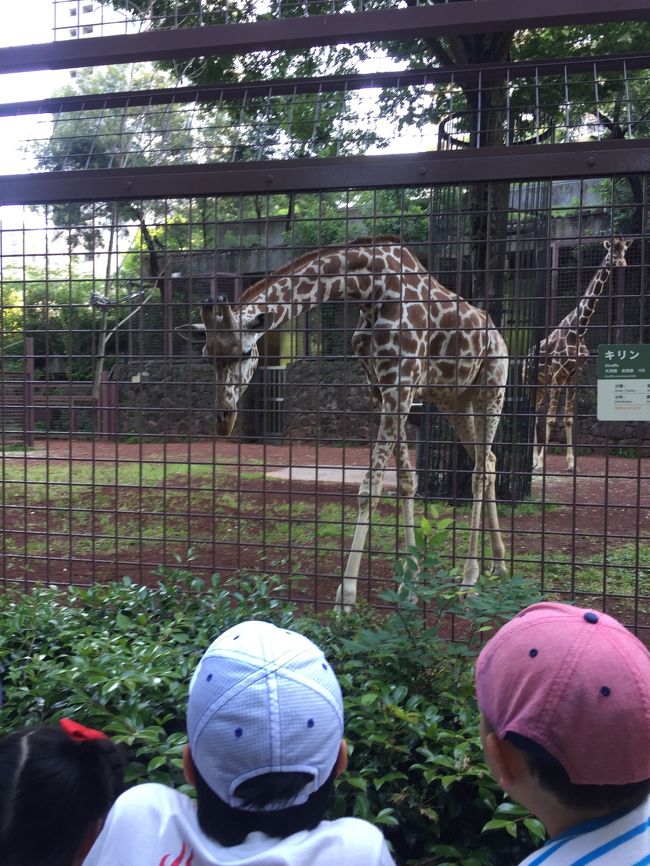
[[519, 798, 650, 866]]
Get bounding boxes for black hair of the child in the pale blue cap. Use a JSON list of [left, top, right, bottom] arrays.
[[194, 765, 336, 848]]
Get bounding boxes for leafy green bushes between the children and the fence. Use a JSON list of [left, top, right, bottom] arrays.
[[0, 512, 542, 866]]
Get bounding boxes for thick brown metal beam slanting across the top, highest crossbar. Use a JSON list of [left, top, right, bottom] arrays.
[[0, 0, 650, 72]]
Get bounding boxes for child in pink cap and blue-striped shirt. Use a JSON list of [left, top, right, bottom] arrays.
[[476, 602, 650, 866]]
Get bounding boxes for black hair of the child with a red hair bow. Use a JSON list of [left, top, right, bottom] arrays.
[[0, 727, 126, 866]]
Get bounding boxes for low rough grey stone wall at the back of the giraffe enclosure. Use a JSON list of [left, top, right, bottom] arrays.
[[113, 357, 650, 456]]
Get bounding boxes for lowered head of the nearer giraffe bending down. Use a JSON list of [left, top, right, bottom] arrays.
[[176, 299, 267, 436]]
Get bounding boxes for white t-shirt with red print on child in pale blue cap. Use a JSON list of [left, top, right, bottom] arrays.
[[83, 783, 395, 866]]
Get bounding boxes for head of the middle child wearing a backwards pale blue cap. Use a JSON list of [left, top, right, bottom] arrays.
[[186, 622, 345, 845]]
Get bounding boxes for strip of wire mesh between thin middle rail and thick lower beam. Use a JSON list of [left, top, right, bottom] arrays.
[[5, 55, 650, 172]]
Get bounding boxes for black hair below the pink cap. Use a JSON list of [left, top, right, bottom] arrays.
[[505, 733, 650, 814]]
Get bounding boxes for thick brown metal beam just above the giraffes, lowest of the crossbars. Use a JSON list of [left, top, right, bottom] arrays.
[[0, 140, 650, 205]]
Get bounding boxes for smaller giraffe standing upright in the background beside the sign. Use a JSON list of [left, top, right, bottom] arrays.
[[524, 238, 632, 472]]
